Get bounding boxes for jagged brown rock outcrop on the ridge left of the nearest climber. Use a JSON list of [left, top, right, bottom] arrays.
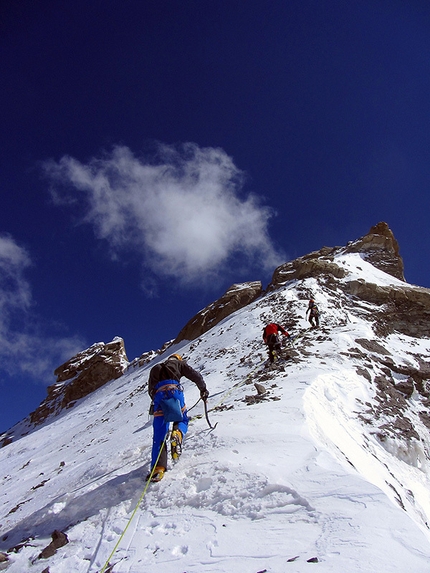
[[30, 337, 128, 425]]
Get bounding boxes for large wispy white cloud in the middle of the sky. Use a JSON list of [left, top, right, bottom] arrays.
[[44, 143, 283, 282]]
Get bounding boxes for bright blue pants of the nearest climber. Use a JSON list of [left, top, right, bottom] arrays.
[[151, 381, 188, 468]]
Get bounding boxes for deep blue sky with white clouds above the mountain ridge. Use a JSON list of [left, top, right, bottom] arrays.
[[0, 0, 430, 429]]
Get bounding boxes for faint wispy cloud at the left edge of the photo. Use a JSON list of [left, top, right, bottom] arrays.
[[0, 235, 83, 383]]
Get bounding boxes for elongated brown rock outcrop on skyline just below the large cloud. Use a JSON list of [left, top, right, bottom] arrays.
[[174, 281, 263, 343]]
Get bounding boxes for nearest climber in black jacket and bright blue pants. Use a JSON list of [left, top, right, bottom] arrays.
[[146, 354, 209, 481]]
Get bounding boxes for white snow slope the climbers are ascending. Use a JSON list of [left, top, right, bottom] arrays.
[[0, 254, 430, 573]]
